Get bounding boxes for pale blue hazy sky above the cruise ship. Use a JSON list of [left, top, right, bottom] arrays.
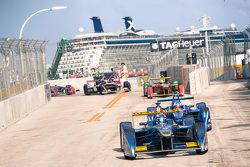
[[0, 0, 250, 63]]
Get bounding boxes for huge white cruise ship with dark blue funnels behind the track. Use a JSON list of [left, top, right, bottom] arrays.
[[49, 16, 250, 78]]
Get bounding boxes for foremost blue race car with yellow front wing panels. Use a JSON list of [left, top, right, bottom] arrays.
[[120, 95, 211, 159]]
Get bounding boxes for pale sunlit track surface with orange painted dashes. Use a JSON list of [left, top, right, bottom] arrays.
[[0, 81, 250, 167]]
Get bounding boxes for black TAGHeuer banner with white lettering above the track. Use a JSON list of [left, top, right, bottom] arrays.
[[151, 37, 206, 52]]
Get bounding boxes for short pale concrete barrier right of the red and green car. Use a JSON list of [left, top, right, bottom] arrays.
[[189, 67, 210, 95]]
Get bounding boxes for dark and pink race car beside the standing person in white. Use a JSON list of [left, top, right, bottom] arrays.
[[83, 73, 121, 95]]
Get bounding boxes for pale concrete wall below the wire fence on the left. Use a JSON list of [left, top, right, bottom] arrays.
[[0, 84, 50, 131]]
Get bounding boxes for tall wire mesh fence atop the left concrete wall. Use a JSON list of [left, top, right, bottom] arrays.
[[0, 38, 47, 101]]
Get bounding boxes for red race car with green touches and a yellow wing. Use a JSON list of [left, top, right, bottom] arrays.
[[143, 77, 183, 98]]
